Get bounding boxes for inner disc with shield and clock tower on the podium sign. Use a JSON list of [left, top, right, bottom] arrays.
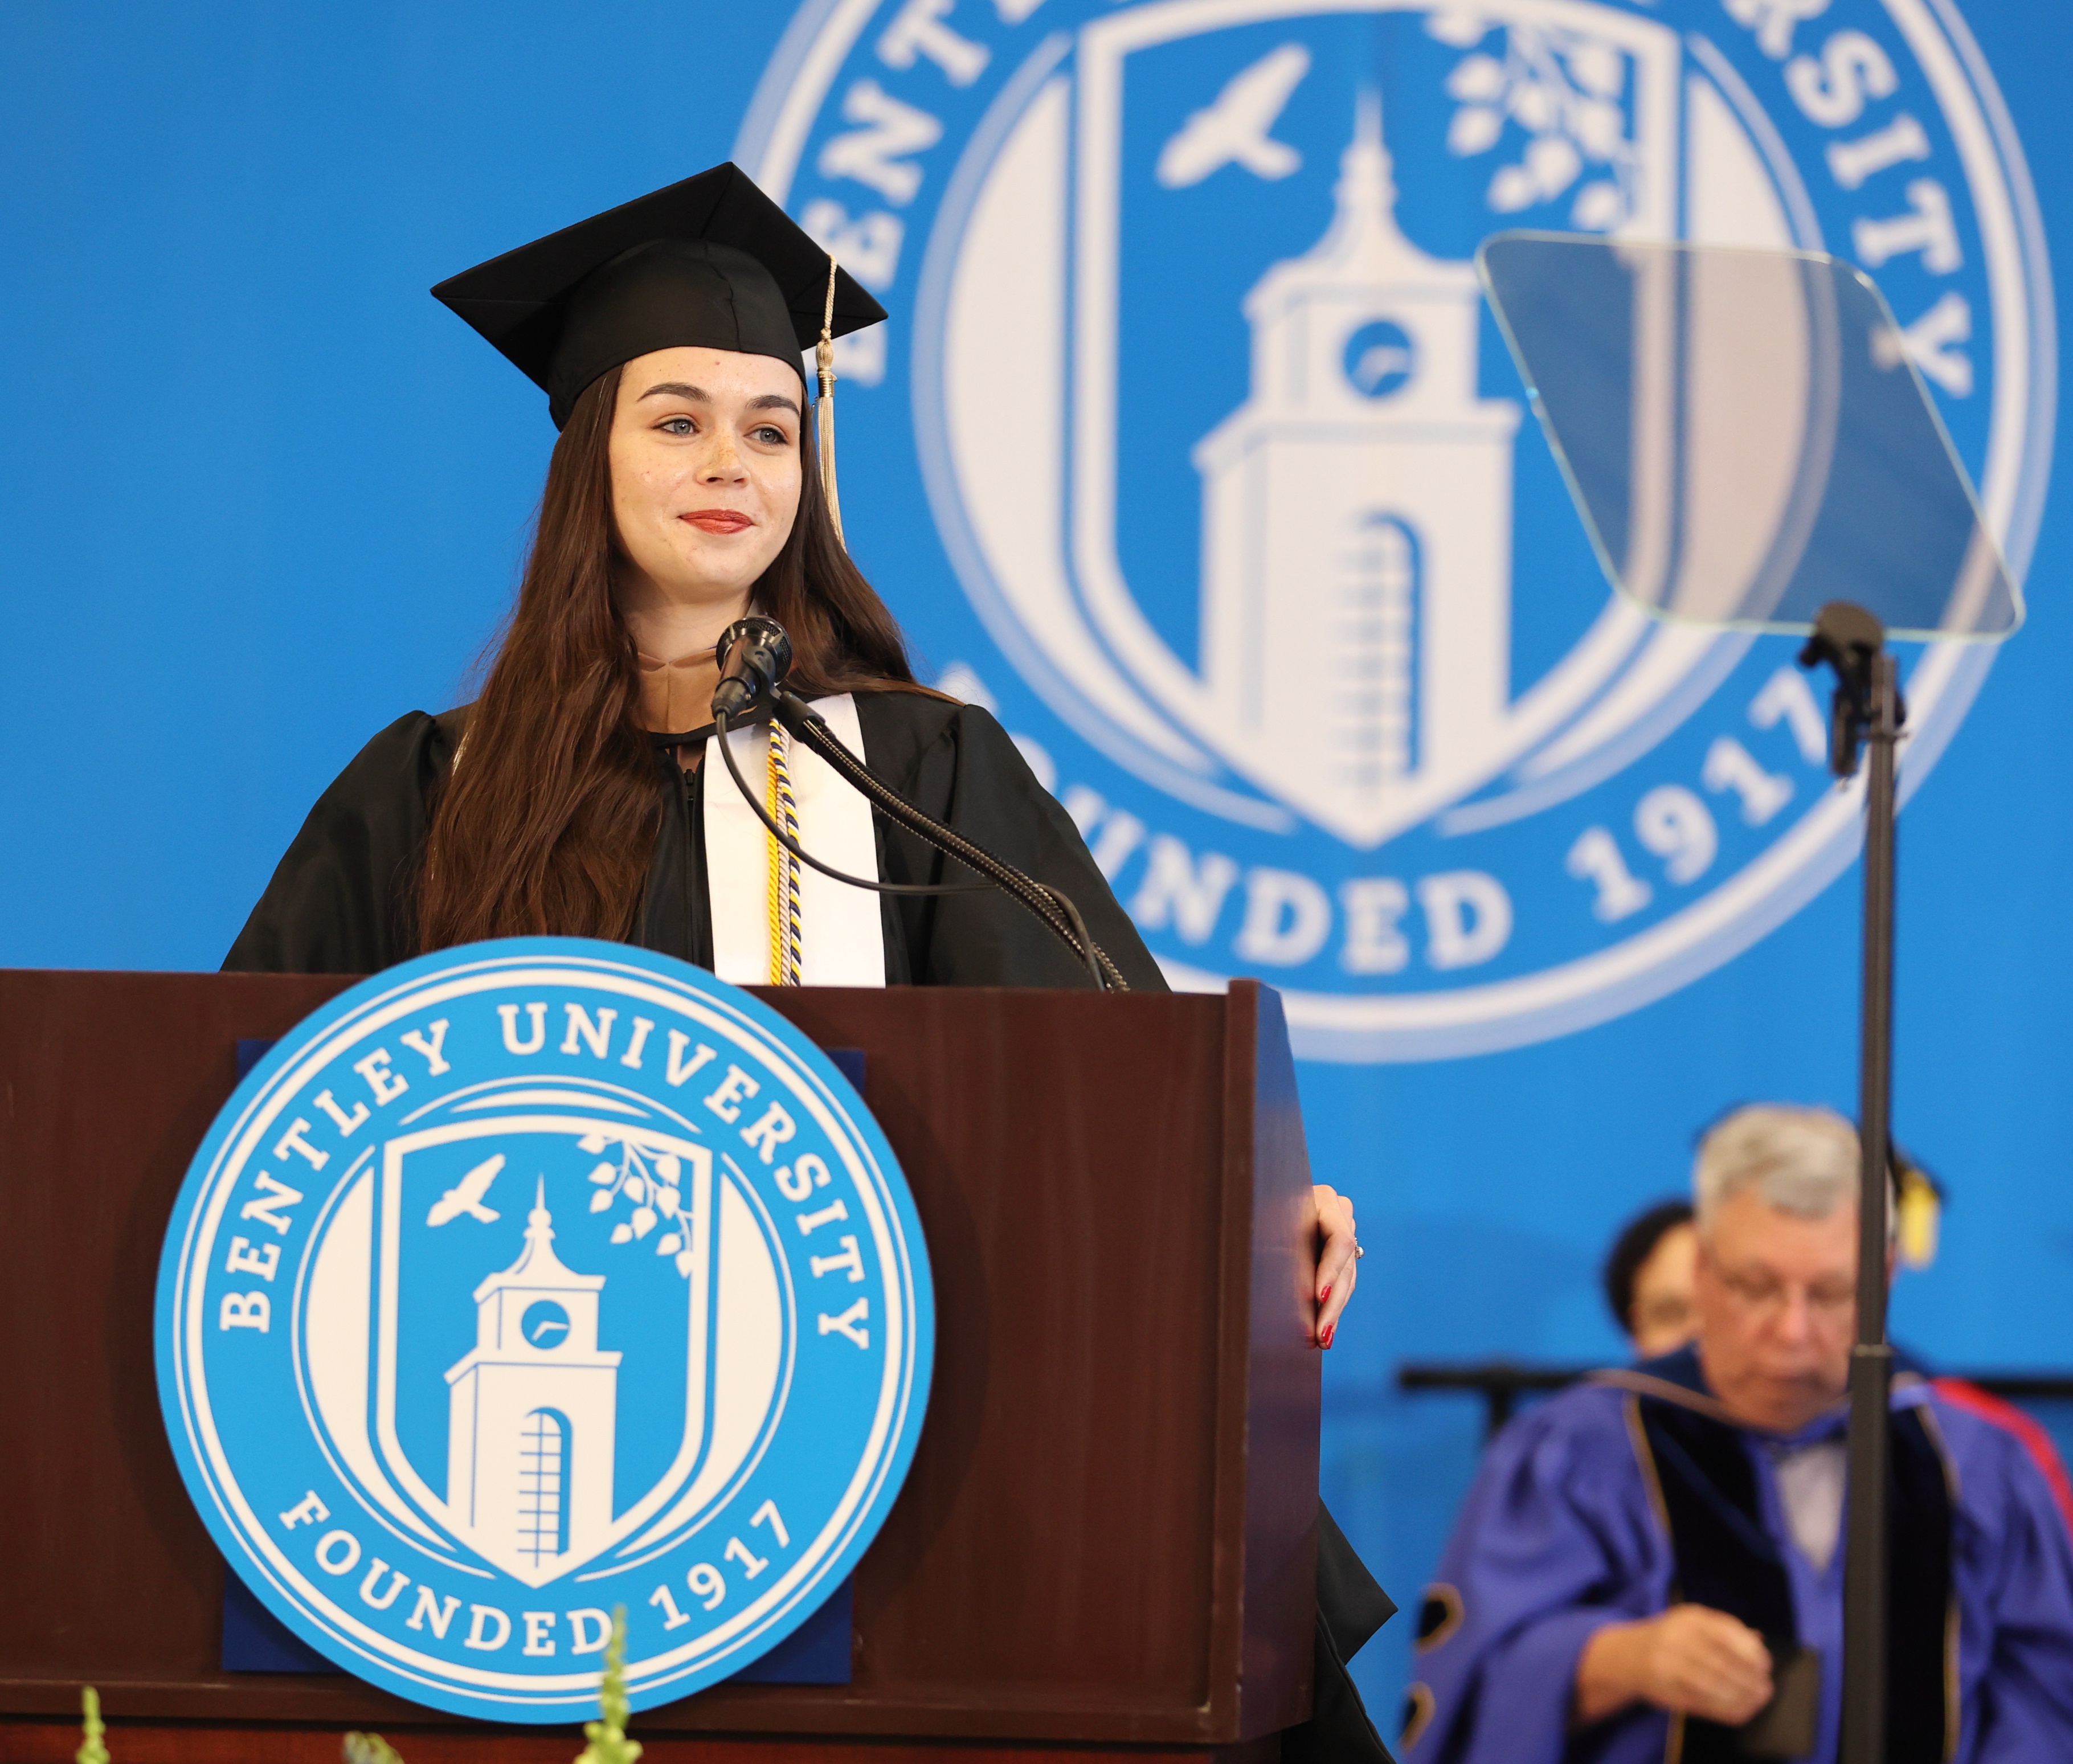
[[301, 1080, 792, 1586]]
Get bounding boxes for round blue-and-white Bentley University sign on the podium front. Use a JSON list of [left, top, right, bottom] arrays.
[[158, 939, 933, 1721]]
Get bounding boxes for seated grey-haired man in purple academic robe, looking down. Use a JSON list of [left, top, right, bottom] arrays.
[[1405, 1107, 2073, 1764]]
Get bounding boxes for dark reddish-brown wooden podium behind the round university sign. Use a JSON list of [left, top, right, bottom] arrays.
[[0, 972, 1318, 1764]]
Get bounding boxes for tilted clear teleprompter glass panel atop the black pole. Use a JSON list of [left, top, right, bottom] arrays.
[[1476, 232, 2023, 641]]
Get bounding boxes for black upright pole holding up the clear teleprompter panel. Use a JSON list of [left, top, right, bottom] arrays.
[[1837, 646, 1901, 1764]]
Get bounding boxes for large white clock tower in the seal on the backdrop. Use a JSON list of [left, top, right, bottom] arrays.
[[1194, 95, 1519, 848]]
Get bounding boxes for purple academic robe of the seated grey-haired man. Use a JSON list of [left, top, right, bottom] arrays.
[[1404, 1381, 2073, 1764]]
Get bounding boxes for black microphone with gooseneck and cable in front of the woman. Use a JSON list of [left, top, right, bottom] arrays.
[[713, 617, 1130, 993]]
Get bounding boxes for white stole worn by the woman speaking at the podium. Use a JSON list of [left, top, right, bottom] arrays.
[[698, 693, 885, 987]]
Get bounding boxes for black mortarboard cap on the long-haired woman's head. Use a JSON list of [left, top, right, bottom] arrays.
[[431, 164, 885, 429]]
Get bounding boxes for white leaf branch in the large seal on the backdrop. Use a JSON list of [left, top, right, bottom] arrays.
[[1426, 9, 1639, 232]]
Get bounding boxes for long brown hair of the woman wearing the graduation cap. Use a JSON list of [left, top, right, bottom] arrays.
[[415, 356, 914, 949]]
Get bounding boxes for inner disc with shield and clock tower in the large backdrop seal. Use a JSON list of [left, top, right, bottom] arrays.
[[918, 0, 1793, 850]]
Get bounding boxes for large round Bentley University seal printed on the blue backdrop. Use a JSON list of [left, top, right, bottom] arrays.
[[738, 0, 2054, 1059]]
